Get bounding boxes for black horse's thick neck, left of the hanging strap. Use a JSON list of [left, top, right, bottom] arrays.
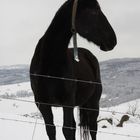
[[30, 1, 72, 74]]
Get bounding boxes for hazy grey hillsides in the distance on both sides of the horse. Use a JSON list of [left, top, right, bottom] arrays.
[[0, 58, 140, 107]]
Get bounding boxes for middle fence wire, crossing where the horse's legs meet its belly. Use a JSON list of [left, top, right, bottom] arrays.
[[0, 97, 140, 116]]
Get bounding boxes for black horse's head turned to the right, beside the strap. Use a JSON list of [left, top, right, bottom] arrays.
[[75, 0, 117, 51]]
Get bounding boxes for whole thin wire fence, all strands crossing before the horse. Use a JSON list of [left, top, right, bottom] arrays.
[[0, 73, 140, 140]]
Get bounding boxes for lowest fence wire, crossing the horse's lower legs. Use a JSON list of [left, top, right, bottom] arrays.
[[0, 117, 140, 139]]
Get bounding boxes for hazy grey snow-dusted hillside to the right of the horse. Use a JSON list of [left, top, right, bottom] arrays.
[[101, 58, 140, 107]]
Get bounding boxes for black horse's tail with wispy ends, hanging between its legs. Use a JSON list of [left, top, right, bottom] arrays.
[[79, 107, 90, 140]]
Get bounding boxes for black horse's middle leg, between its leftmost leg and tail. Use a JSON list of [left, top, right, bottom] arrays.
[[63, 107, 76, 140]]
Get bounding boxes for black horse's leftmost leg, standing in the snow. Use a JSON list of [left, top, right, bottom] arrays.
[[38, 104, 56, 140]]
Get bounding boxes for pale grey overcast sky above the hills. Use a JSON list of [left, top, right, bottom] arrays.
[[0, 0, 140, 65]]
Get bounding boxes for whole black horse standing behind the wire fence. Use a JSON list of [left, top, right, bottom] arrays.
[[30, 0, 117, 140]]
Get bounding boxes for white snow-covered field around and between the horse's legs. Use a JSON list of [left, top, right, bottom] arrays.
[[0, 83, 140, 140]]
